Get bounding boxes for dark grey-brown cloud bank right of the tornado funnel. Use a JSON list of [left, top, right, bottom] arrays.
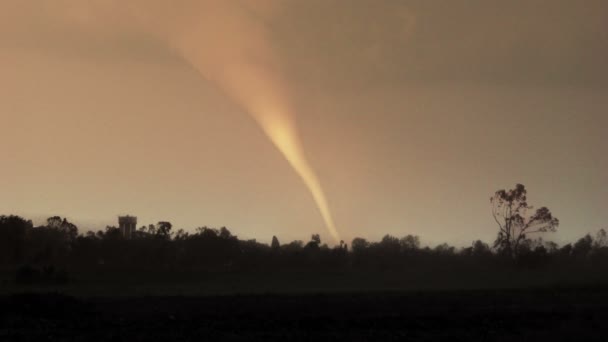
[[276, 0, 608, 86]]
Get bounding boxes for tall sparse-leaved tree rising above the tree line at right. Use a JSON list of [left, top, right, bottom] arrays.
[[490, 184, 559, 255]]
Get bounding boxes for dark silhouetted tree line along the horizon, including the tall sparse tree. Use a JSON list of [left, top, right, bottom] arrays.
[[0, 184, 608, 280]]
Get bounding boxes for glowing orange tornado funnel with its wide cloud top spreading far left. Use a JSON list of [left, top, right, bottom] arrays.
[[11, 0, 340, 242]]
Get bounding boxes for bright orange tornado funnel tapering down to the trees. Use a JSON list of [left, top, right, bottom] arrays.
[[143, 0, 340, 242]]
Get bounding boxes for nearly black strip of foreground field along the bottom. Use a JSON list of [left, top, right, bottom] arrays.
[[0, 289, 608, 341]]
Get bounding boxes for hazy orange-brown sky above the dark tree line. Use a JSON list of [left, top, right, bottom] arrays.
[[0, 0, 608, 246]]
